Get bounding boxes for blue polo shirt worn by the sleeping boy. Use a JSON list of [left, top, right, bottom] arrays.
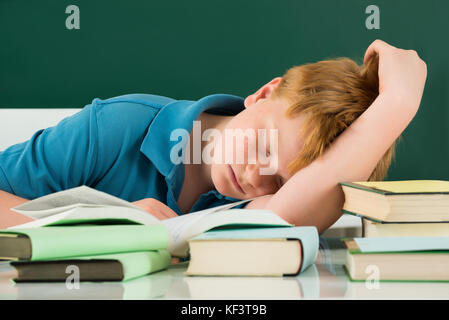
[[0, 94, 244, 214]]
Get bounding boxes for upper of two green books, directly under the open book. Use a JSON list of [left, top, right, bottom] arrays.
[[0, 225, 169, 261]]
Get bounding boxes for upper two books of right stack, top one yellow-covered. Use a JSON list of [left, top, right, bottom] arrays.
[[340, 180, 449, 237]]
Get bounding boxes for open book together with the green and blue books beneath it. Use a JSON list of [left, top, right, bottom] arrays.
[[0, 186, 319, 282]]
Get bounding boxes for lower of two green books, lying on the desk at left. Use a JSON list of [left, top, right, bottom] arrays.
[[11, 249, 171, 283]]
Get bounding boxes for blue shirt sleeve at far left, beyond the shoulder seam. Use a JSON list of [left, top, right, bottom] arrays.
[[0, 100, 98, 199]]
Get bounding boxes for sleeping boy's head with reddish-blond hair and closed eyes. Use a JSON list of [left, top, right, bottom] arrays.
[[211, 57, 395, 199]]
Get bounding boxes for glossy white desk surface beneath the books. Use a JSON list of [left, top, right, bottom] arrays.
[[0, 238, 449, 300]]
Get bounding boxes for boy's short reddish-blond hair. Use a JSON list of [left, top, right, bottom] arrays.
[[272, 56, 396, 181]]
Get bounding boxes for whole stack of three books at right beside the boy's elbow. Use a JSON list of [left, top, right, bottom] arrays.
[[340, 180, 449, 281]]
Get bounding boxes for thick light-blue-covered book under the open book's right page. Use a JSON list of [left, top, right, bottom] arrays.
[[186, 227, 319, 276]]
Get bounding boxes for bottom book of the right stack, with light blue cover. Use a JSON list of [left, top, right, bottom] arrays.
[[344, 237, 449, 281]]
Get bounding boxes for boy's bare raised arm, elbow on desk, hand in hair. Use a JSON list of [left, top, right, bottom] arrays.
[[246, 40, 427, 232]]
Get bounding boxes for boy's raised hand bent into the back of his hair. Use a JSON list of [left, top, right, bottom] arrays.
[[364, 40, 427, 113]]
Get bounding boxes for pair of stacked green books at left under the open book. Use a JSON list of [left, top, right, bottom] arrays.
[[0, 225, 171, 282]]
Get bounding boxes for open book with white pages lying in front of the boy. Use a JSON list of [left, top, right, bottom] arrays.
[[10, 186, 292, 257]]
